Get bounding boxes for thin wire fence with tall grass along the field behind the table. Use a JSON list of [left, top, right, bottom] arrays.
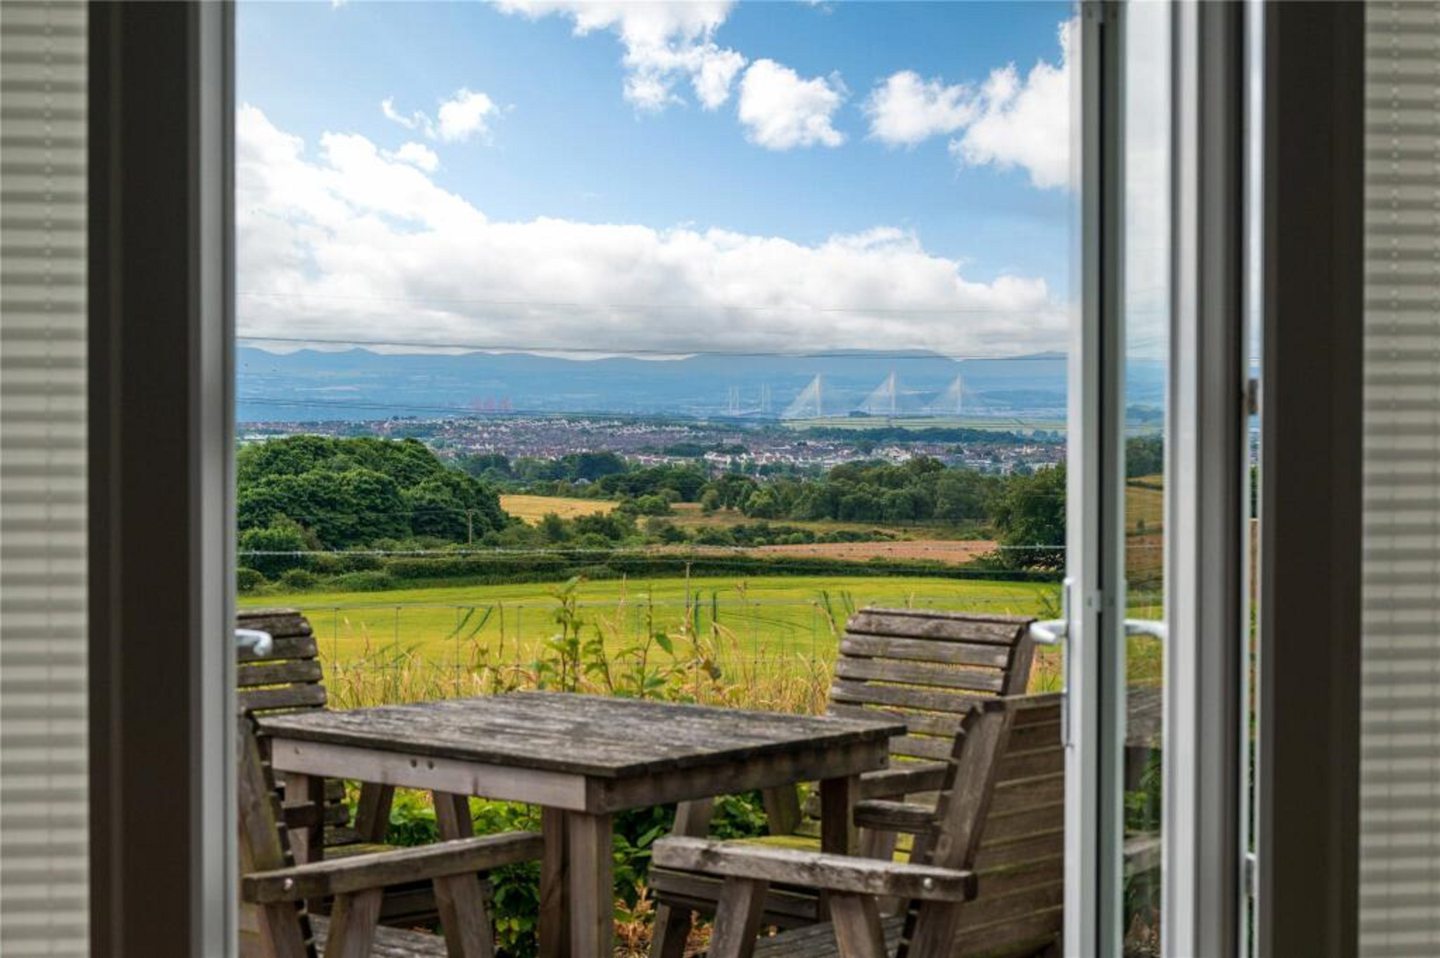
[[286, 588, 1054, 710]]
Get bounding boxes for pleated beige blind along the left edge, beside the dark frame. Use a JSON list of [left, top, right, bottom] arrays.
[[0, 1, 89, 958]]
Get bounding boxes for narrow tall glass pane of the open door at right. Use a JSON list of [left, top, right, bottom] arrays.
[[1122, 3, 1171, 957]]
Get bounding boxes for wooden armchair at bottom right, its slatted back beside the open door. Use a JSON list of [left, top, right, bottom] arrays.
[[654, 693, 1064, 958]]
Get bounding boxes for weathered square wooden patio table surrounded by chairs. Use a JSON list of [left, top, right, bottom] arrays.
[[259, 691, 904, 958]]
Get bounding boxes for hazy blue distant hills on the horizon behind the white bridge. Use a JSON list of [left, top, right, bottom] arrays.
[[236, 347, 1164, 422]]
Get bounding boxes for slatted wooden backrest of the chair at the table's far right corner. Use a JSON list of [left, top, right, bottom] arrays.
[[829, 608, 1034, 762]]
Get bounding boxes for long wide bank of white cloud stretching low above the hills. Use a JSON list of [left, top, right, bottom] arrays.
[[236, 105, 1067, 356]]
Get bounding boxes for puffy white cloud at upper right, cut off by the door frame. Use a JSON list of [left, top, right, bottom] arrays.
[[864, 20, 1077, 189]]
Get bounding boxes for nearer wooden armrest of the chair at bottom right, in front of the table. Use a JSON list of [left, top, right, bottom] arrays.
[[651, 837, 975, 902]]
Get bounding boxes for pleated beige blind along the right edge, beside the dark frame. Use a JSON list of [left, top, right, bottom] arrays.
[[1365, 1, 1440, 958]]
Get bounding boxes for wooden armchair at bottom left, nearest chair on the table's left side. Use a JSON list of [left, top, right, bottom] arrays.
[[236, 713, 544, 958]]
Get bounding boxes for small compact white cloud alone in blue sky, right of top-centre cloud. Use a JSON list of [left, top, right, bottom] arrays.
[[739, 61, 845, 150]]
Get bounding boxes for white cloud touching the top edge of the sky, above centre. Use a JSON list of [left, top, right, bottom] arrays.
[[497, 0, 746, 112]]
